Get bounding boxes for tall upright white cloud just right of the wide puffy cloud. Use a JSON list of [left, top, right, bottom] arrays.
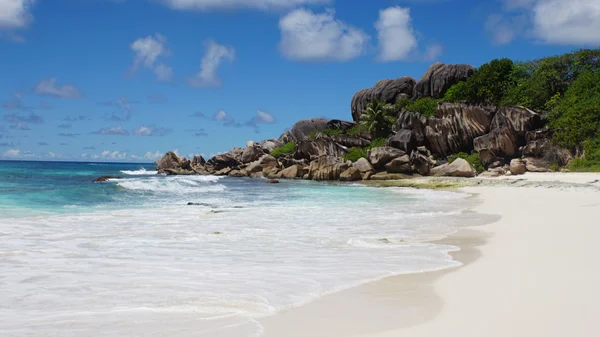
[[375, 6, 418, 62]]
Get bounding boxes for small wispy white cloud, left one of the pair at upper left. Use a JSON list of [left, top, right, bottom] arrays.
[[129, 33, 173, 81]]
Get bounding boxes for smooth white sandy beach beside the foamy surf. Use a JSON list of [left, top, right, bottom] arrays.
[[261, 174, 600, 337]]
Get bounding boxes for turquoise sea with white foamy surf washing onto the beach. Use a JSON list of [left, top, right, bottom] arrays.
[[0, 161, 478, 337]]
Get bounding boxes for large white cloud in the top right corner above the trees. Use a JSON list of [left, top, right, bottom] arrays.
[[492, 0, 600, 46]]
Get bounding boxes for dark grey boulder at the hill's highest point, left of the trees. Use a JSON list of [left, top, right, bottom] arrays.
[[412, 62, 475, 99]]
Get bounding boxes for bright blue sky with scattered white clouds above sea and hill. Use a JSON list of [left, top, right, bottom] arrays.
[[0, 0, 600, 162]]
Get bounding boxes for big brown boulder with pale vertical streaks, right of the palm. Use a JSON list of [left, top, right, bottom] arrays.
[[425, 103, 496, 157]]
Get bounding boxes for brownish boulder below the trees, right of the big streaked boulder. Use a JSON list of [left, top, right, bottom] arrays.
[[473, 126, 518, 166]]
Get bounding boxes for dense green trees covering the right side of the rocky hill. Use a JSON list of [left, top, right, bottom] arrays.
[[438, 49, 600, 171]]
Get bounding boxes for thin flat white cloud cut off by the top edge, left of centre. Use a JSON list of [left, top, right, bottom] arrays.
[[162, 0, 332, 10]]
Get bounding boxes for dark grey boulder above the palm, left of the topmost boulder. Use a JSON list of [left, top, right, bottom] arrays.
[[351, 76, 416, 122]]
